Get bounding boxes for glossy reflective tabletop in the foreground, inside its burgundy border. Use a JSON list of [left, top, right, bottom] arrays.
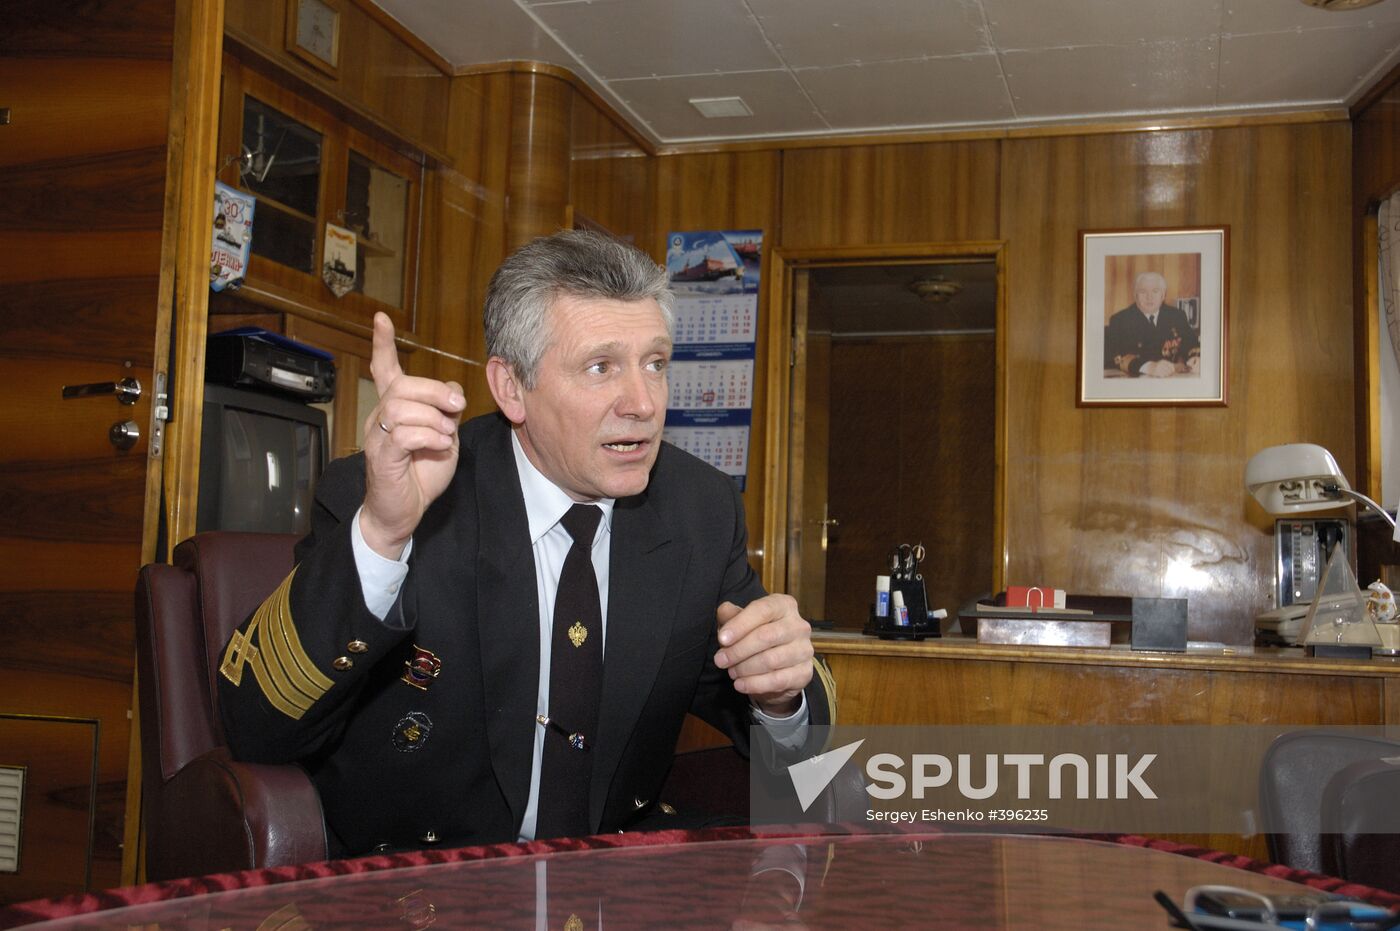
[[0, 834, 1355, 931]]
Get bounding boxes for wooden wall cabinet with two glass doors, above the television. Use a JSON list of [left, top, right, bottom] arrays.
[[218, 59, 424, 332]]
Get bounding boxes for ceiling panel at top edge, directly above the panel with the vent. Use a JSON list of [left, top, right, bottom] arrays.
[[529, 0, 783, 80]]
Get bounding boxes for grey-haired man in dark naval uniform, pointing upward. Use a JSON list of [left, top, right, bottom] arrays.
[[218, 231, 833, 854]]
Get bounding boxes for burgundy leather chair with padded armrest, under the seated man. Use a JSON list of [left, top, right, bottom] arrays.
[[136, 532, 326, 881]]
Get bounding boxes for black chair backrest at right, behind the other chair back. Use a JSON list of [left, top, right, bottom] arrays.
[[1259, 731, 1400, 872]]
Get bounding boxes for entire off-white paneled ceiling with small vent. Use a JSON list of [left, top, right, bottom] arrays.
[[374, 0, 1400, 144]]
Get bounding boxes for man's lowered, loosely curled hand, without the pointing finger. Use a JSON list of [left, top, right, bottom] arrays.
[[714, 595, 812, 717]]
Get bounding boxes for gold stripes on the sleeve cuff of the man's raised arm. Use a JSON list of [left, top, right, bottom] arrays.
[[218, 570, 335, 721]]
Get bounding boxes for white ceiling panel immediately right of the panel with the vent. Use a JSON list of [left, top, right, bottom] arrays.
[[798, 53, 1012, 132]]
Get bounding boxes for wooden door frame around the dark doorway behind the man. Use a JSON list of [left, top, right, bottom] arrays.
[[762, 241, 1008, 591]]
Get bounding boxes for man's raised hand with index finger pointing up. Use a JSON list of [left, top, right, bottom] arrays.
[[360, 314, 466, 559]]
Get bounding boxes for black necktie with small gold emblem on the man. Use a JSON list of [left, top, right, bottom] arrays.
[[535, 504, 603, 839]]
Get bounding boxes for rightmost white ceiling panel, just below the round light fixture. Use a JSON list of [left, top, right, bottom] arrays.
[[1219, 27, 1400, 105]]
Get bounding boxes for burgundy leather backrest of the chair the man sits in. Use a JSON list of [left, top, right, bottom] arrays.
[[136, 532, 298, 794]]
